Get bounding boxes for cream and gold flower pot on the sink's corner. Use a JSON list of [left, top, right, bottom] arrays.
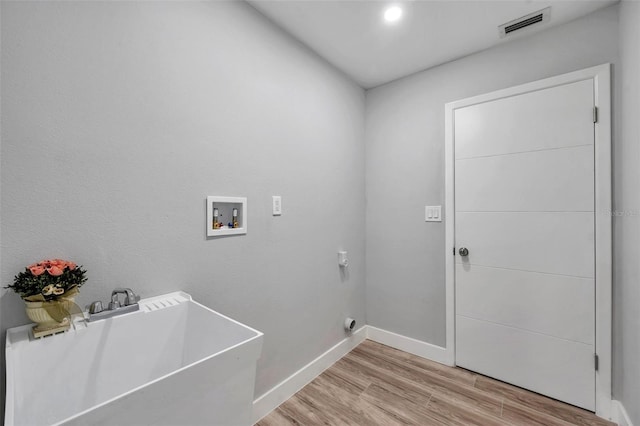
[[25, 298, 75, 338]]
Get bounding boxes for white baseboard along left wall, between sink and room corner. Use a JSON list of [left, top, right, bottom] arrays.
[[253, 325, 367, 423]]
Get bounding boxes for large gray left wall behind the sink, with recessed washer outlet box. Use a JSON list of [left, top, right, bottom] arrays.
[[0, 2, 365, 414]]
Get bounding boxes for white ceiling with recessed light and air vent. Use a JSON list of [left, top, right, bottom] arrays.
[[247, 0, 617, 88]]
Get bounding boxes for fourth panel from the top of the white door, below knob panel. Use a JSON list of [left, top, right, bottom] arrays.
[[456, 264, 595, 344]]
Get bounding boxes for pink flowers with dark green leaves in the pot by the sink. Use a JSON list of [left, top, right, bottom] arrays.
[[5, 259, 87, 302]]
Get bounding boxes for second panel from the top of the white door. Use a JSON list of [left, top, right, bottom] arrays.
[[455, 145, 593, 212]]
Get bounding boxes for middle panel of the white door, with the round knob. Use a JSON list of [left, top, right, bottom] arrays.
[[456, 212, 595, 278]]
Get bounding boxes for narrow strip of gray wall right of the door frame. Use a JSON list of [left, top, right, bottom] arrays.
[[613, 1, 640, 425]]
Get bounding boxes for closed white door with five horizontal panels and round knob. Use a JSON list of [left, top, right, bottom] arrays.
[[454, 79, 595, 411]]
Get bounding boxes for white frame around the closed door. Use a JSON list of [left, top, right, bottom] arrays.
[[445, 63, 612, 418]]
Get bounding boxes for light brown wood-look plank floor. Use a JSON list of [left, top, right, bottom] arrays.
[[257, 340, 614, 426]]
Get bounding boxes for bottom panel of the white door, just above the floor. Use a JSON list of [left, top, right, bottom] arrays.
[[456, 316, 595, 409]]
